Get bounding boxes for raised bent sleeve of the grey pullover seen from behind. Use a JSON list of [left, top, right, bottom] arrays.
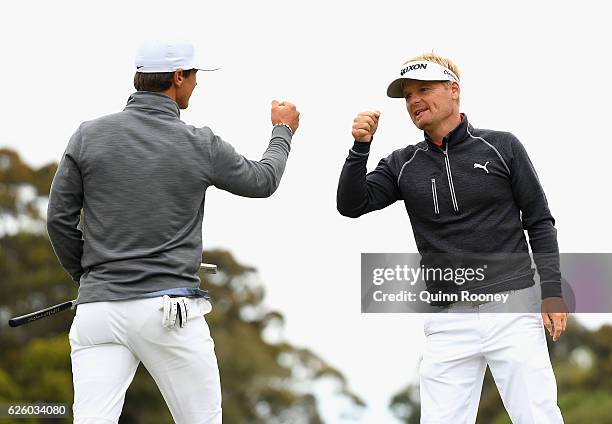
[[210, 126, 291, 197]]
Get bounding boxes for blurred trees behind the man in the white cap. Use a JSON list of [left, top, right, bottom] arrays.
[[0, 149, 364, 424]]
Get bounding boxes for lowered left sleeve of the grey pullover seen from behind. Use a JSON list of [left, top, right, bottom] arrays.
[[47, 129, 83, 283]]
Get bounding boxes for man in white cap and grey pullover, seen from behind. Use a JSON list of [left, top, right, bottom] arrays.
[[47, 41, 299, 424]]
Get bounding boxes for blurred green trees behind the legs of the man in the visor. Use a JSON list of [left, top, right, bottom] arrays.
[[390, 317, 612, 424]]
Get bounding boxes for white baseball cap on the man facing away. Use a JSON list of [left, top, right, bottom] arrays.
[[134, 40, 219, 74]]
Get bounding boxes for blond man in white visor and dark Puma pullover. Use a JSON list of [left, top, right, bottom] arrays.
[[337, 53, 567, 424]]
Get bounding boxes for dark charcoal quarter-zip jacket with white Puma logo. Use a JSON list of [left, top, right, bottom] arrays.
[[337, 115, 561, 298]]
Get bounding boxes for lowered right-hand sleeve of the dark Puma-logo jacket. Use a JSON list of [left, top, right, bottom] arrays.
[[510, 135, 561, 299]]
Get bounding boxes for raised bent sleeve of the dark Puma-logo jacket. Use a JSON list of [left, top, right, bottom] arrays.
[[336, 141, 400, 218]]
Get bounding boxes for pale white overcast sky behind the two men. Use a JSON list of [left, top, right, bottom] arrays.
[[0, 0, 612, 423]]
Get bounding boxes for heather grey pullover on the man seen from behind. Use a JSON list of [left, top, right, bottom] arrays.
[[47, 92, 291, 303]]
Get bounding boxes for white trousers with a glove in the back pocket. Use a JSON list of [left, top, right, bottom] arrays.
[[69, 297, 221, 424]]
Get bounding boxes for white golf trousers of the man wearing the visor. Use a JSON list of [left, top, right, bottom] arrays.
[[420, 287, 563, 424]]
